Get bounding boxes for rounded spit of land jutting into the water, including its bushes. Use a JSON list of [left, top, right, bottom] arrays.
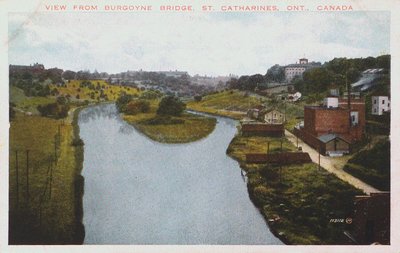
[[116, 95, 216, 143]]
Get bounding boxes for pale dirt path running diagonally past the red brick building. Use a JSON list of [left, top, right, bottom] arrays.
[[285, 130, 379, 194]]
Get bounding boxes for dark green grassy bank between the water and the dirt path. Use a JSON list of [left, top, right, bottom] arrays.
[[227, 137, 362, 245]]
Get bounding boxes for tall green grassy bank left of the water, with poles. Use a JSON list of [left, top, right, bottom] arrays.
[[9, 108, 84, 244]]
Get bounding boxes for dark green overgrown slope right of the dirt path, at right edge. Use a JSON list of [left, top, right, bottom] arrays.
[[344, 139, 390, 191]]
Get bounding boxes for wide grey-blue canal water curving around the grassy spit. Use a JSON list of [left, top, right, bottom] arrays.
[[79, 104, 282, 245]]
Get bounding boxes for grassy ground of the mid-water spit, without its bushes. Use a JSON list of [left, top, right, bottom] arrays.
[[123, 100, 216, 143]]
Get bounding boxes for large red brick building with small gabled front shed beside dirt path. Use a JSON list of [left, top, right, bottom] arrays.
[[294, 97, 365, 155]]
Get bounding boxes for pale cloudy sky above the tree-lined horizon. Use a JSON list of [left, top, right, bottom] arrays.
[[8, 12, 390, 76]]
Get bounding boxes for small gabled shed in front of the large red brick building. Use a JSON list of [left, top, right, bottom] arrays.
[[318, 134, 350, 156]]
